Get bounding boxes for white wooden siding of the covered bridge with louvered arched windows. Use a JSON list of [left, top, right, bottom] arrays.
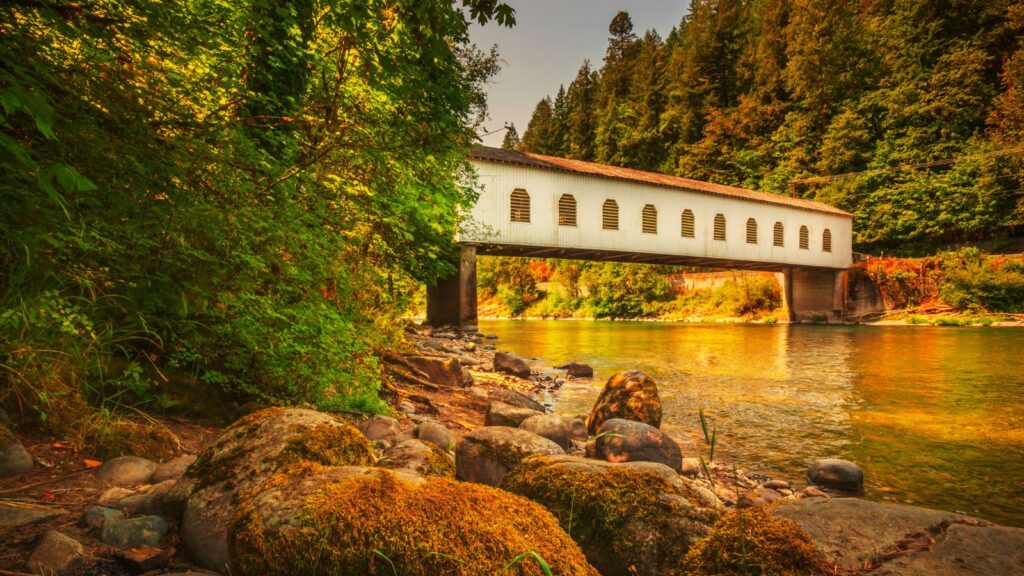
[[459, 159, 852, 270]]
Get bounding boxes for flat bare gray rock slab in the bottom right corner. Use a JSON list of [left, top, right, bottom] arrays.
[[774, 498, 1024, 576]]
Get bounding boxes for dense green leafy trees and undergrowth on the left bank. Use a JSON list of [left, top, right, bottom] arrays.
[[0, 0, 514, 434]]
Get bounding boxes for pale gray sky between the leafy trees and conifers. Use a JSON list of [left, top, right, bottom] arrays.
[[470, 0, 689, 147]]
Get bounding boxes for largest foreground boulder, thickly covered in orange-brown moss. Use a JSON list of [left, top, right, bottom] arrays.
[[231, 463, 597, 576]]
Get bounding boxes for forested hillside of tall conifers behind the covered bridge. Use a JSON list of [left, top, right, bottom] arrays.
[[520, 0, 1024, 253]]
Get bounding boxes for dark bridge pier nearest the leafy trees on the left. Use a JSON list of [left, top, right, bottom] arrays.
[[427, 246, 476, 332]]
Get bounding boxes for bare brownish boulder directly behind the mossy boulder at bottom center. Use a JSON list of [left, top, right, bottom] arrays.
[[455, 426, 564, 486]]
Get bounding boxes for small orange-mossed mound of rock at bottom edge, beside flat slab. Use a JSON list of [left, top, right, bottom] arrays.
[[672, 506, 826, 576]]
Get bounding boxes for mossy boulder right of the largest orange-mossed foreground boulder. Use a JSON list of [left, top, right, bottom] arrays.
[[501, 456, 721, 576]]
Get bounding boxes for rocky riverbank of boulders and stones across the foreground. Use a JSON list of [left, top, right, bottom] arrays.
[[0, 325, 1024, 576]]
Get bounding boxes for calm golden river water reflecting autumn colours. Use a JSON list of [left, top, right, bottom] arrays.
[[480, 320, 1024, 526]]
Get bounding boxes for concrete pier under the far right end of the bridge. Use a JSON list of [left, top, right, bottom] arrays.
[[781, 269, 847, 322]]
